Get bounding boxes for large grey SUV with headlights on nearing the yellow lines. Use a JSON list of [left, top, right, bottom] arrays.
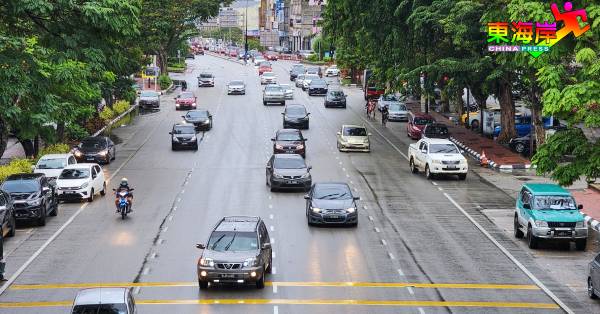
[[196, 216, 273, 290]]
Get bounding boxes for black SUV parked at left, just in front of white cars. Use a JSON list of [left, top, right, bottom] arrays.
[[0, 173, 58, 226]]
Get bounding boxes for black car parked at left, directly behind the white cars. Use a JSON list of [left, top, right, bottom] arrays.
[[73, 136, 117, 164]]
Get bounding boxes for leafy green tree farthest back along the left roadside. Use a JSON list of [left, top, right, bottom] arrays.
[[142, 0, 231, 73]]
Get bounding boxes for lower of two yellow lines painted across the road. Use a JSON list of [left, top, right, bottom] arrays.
[[0, 299, 559, 309]]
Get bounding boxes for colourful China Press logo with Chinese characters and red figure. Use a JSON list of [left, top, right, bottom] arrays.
[[486, 2, 590, 58]]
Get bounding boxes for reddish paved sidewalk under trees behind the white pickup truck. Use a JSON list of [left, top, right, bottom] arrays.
[[407, 102, 531, 170]]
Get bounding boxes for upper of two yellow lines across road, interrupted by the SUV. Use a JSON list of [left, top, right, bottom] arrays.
[[9, 281, 540, 290]]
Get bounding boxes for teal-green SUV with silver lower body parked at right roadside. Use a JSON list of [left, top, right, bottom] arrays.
[[514, 183, 588, 251]]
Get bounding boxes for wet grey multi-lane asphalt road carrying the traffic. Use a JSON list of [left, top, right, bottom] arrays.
[[0, 56, 600, 313]]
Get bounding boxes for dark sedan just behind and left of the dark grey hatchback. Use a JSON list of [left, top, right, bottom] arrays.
[[266, 154, 312, 192]]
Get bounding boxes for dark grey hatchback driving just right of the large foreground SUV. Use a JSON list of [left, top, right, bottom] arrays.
[[304, 182, 360, 226]]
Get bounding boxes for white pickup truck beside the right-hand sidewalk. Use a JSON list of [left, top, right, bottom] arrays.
[[408, 138, 469, 180]]
